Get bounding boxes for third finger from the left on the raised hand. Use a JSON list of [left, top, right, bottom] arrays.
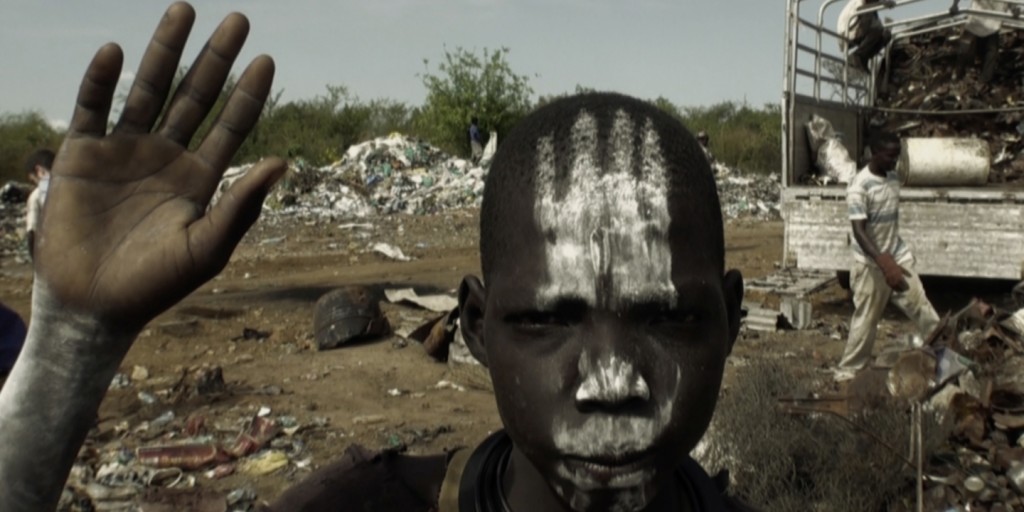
[[158, 13, 249, 145]]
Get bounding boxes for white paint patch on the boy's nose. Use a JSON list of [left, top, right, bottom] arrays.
[[575, 350, 650, 403]]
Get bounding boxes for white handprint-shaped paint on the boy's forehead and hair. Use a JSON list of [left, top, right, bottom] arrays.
[[535, 111, 676, 309]]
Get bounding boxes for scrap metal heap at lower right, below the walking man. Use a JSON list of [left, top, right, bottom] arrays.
[[890, 300, 1024, 510]]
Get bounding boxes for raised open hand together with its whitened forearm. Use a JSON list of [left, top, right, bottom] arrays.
[[0, 3, 286, 512]]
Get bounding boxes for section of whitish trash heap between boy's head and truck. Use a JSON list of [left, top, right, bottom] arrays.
[[715, 173, 781, 220]]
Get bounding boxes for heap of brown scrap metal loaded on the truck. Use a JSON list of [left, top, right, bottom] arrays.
[[871, 28, 1024, 186]]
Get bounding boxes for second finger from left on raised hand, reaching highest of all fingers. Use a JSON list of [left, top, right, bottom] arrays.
[[115, 2, 196, 133]]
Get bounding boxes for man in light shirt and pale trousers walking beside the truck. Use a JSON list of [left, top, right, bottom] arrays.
[[836, 133, 939, 381]]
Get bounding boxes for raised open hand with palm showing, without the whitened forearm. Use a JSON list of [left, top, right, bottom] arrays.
[[36, 3, 286, 329]]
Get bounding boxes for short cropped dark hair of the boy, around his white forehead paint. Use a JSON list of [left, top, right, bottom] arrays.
[[480, 92, 725, 281]]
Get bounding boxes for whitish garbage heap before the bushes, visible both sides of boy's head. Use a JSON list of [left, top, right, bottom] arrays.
[[214, 134, 779, 224]]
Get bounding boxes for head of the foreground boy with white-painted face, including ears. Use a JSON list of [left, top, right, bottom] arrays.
[[460, 94, 742, 510]]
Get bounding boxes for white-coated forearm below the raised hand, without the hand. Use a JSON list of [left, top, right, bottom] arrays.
[[0, 280, 136, 512]]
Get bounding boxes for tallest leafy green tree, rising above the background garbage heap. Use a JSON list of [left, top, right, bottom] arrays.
[[416, 47, 534, 155]]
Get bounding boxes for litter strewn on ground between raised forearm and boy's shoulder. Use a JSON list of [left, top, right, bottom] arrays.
[[58, 366, 319, 511]]
